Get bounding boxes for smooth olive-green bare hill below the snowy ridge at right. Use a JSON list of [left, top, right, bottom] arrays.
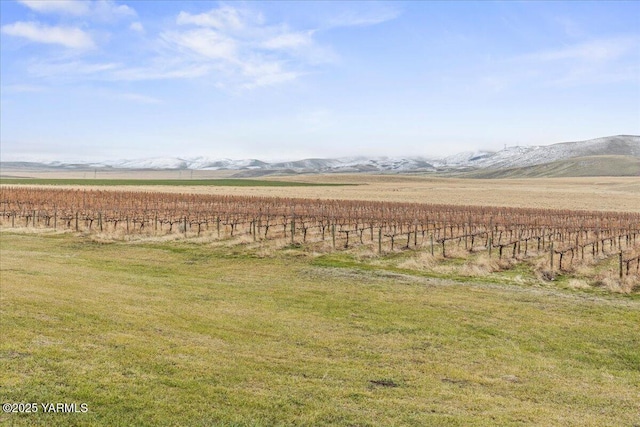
[[464, 156, 640, 179]]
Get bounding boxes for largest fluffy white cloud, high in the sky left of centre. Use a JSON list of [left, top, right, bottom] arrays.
[[161, 5, 335, 89]]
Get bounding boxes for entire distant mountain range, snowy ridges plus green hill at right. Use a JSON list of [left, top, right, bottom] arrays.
[[0, 135, 640, 178]]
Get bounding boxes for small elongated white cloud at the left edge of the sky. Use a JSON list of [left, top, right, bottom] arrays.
[[2, 21, 95, 49]]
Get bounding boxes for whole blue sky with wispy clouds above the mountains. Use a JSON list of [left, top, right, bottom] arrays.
[[0, 0, 640, 161]]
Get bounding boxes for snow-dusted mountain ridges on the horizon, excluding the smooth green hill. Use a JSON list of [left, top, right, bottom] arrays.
[[2, 135, 640, 175]]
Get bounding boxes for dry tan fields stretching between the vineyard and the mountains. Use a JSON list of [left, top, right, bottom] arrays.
[[3, 171, 640, 212]]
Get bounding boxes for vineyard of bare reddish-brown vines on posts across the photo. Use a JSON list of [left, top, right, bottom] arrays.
[[0, 187, 640, 275]]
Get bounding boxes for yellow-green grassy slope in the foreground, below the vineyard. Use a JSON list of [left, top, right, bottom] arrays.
[[0, 233, 640, 426]]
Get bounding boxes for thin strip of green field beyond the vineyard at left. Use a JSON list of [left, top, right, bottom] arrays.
[[0, 178, 355, 187]]
